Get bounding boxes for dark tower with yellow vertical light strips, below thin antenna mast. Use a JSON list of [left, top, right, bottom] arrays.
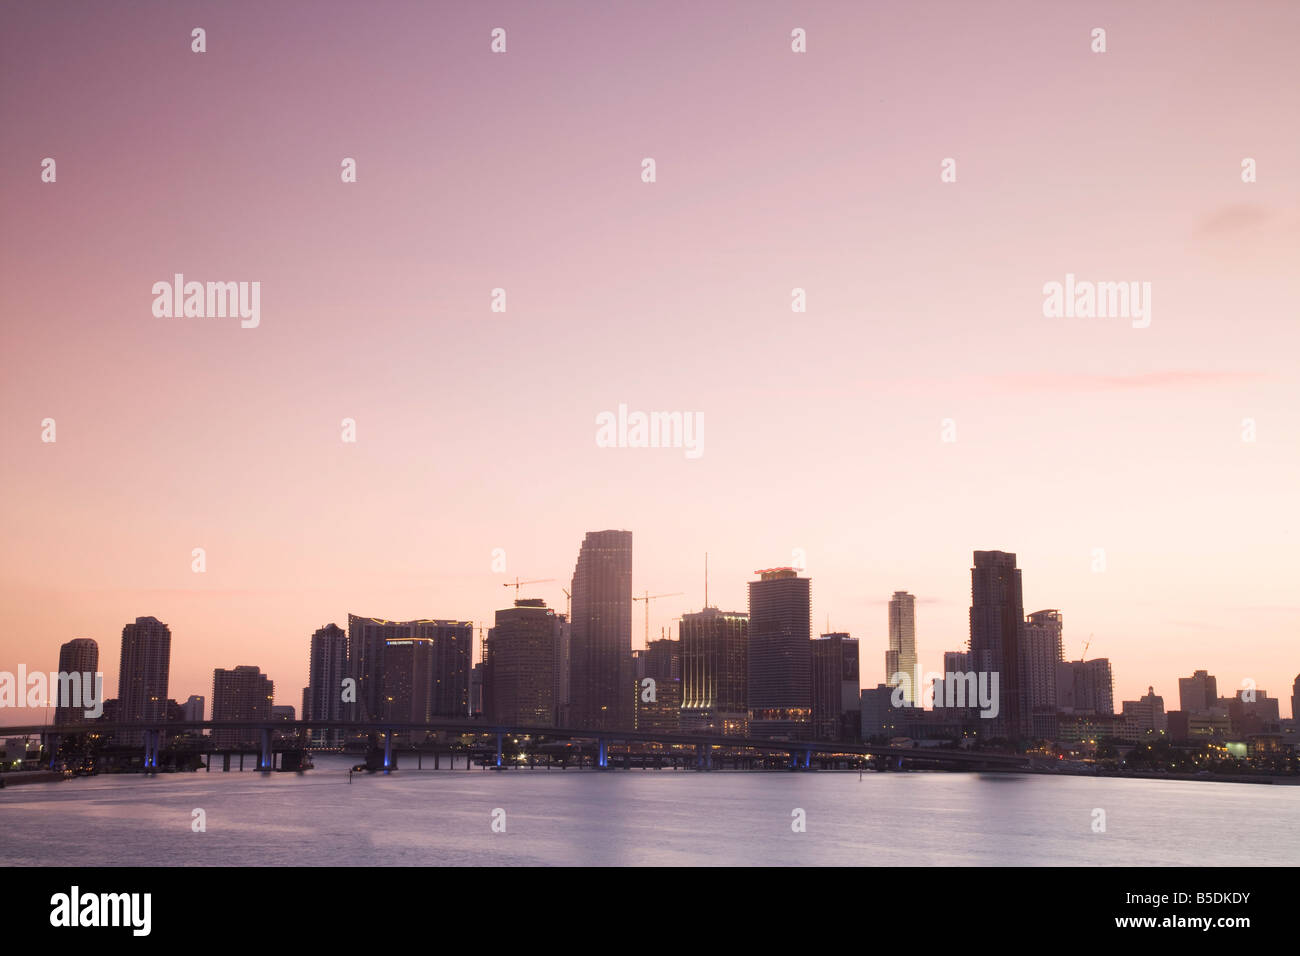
[[677, 607, 749, 736]]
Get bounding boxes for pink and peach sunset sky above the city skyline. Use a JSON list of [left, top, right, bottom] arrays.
[[0, 3, 1300, 723]]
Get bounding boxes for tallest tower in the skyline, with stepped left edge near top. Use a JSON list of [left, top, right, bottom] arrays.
[[569, 531, 633, 728]]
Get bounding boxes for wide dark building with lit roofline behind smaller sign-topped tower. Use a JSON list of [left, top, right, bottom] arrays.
[[347, 614, 473, 721]]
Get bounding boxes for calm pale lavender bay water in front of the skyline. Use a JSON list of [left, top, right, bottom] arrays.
[[0, 757, 1300, 866]]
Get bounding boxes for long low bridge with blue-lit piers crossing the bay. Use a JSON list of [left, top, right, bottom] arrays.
[[0, 718, 1030, 771]]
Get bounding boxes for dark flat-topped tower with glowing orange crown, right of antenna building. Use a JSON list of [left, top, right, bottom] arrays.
[[749, 567, 813, 740]]
